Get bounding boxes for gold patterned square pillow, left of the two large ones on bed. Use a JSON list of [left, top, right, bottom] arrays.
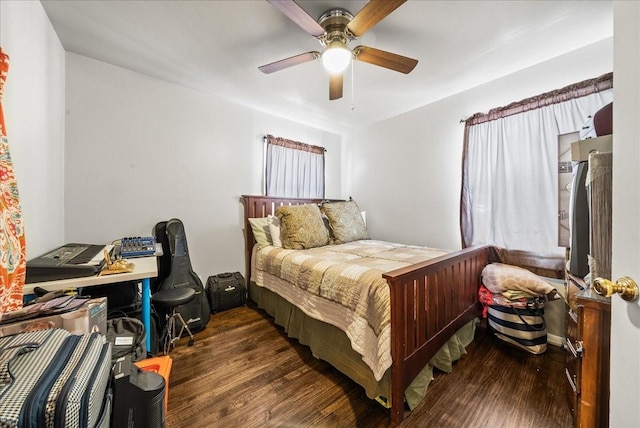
[[275, 204, 329, 250]]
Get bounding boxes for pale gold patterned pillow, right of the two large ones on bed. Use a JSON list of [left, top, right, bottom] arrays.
[[321, 201, 369, 244]]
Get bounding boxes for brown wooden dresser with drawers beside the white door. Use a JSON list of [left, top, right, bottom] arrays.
[[565, 274, 611, 428]]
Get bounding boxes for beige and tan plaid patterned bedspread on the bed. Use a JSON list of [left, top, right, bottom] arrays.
[[253, 240, 447, 380]]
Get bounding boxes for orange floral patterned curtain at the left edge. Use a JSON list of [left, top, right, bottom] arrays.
[[0, 47, 27, 317]]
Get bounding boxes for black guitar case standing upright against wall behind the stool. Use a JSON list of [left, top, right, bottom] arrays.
[[157, 218, 211, 334]]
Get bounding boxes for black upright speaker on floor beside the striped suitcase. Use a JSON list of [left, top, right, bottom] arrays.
[[111, 356, 166, 428]]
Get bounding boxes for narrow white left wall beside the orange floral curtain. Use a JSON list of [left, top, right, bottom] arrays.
[[0, 0, 65, 259]]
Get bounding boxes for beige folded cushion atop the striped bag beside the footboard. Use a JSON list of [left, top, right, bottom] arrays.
[[482, 263, 556, 296]]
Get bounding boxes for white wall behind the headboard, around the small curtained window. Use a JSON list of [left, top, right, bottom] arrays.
[[65, 53, 342, 279]]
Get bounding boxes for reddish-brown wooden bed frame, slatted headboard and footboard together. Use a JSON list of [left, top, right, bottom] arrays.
[[241, 195, 490, 424]]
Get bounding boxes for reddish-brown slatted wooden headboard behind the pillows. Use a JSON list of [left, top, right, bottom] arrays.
[[240, 195, 338, 287]]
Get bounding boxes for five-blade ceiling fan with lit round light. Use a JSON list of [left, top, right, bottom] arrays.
[[258, 0, 418, 100]]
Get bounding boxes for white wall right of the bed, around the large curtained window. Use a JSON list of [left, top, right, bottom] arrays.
[[343, 39, 613, 249]]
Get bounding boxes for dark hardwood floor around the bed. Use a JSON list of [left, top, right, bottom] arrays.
[[167, 305, 571, 428]]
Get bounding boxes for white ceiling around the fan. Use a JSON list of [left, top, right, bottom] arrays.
[[42, 0, 613, 130]]
